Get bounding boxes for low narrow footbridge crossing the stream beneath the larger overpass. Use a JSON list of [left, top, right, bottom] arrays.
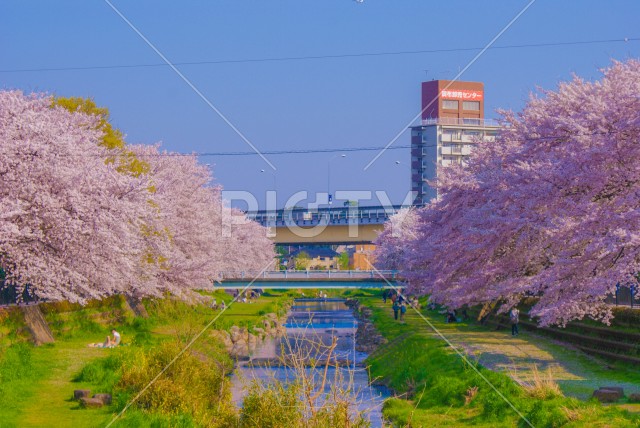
[[213, 270, 404, 289]]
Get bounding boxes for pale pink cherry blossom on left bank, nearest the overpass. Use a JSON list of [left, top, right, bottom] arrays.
[[131, 146, 275, 293]]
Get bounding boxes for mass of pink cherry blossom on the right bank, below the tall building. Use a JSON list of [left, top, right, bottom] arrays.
[[396, 60, 640, 325]]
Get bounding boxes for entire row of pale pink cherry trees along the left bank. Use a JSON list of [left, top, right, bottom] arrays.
[[0, 91, 274, 302]]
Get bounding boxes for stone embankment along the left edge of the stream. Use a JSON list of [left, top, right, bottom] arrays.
[[210, 313, 286, 360]]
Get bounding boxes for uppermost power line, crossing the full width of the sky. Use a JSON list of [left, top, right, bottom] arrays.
[[0, 37, 640, 73]]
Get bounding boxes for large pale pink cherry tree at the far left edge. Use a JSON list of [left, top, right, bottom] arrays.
[[0, 91, 155, 302]]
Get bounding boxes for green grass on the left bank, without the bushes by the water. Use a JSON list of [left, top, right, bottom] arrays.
[[0, 292, 295, 428]]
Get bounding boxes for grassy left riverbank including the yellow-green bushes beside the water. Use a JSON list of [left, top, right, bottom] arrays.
[[0, 291, 293, 428]]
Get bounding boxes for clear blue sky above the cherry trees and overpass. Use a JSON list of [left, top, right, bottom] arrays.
[[0, 0, 640, 206]]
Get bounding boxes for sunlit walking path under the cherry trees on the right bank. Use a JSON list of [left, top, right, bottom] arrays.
[[374, 301, 640, 402]]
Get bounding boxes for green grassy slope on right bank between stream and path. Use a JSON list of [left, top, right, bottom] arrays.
[[358, 293, 640, 427]]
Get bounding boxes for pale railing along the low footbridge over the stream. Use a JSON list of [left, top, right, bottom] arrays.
[[215, 270, 398, 281]]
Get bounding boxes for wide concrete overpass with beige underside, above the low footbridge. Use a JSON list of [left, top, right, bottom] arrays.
[[247, 205, 404, 245]]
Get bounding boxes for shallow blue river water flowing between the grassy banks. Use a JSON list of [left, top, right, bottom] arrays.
[[232, 299, 389, 427]]
